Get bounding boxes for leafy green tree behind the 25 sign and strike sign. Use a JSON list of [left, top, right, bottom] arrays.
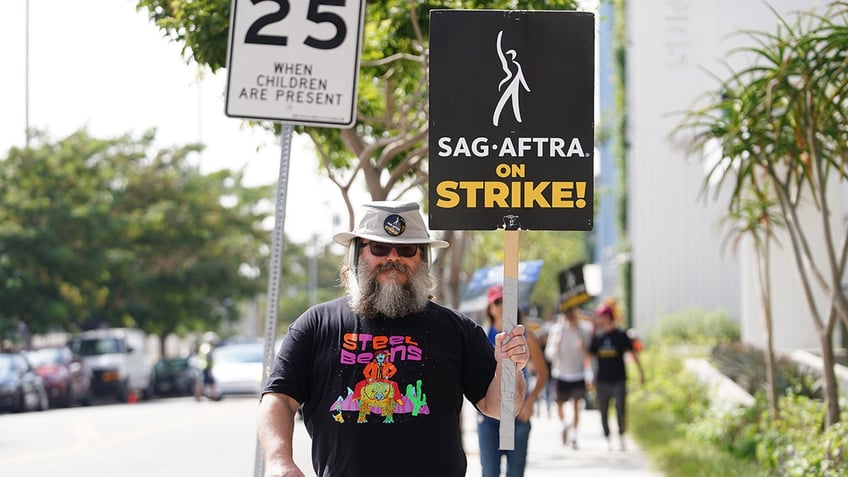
[[136, 0, 577, 306]]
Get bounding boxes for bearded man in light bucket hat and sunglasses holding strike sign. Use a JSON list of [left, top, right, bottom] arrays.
[[257, 202, 530, 477]]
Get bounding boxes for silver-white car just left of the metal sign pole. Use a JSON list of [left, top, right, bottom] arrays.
[[212, 342, 264, 396]]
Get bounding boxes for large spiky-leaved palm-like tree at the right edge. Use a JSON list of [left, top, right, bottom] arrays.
[[676, 1, 848, 426]]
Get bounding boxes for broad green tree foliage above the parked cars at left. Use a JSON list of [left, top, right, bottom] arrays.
[[0, 131, 270, 335]]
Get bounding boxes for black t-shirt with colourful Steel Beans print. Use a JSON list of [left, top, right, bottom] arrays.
[[264, 297, 496, 477]]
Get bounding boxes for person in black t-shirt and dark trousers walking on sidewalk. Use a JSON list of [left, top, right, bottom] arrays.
[[589, 302, 645, 450]]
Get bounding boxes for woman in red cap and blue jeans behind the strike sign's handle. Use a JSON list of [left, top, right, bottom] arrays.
[[477, 285, 548, 477]]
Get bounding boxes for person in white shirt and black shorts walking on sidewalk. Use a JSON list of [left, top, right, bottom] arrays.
[[545, 308, 592, 449]]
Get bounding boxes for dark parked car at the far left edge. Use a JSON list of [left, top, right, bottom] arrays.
[[0, 353, 50, 412]]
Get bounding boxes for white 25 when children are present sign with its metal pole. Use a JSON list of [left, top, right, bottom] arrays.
[[229, 0, 365, 470]]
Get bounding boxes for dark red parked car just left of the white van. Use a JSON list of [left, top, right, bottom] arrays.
[[26, 346, 94, 407]]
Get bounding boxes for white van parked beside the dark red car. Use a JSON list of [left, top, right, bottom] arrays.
[[70, 328, 153, 402]]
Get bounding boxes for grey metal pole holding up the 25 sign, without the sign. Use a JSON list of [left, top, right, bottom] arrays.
[[253, 124, 293, 477]]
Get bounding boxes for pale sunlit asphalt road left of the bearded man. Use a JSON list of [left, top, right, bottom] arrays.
[[0, 396, 312, 477]]
